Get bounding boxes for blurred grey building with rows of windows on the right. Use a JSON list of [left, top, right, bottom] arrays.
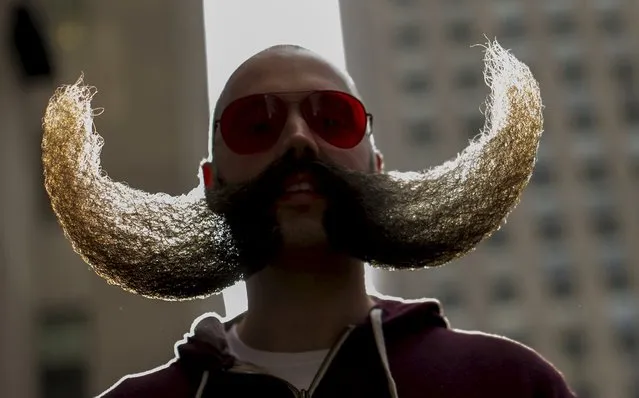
[[341, 0, 639, 398]]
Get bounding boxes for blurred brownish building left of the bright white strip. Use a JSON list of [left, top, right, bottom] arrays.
[[0, 0, 223, 398]]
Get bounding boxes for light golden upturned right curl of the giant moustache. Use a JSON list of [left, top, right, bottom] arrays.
[[364, 42, 543, 269]]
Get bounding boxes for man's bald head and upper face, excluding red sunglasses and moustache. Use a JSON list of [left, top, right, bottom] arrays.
[[209, 45, 382, 182]]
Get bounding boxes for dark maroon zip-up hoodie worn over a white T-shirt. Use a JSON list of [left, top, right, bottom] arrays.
[[101, 299, 576, 398]]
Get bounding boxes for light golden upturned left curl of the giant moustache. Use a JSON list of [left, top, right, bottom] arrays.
[[42, 78, 242, 300]]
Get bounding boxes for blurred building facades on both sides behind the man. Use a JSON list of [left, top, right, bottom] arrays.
[[0, 0, 639, 398]]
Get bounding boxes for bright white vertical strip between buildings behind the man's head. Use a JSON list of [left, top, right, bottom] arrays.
[[204, 0, 362, 317]]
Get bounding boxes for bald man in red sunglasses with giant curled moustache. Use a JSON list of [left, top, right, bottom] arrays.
[[43, 42, 574, 398]]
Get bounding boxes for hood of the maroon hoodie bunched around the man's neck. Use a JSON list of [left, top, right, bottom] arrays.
[[177, 296, 449, 372]]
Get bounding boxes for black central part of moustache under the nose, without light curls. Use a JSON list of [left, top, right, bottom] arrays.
[[206, 152, 369, 275]]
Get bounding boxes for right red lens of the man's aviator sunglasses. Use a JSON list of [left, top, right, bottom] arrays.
[[300, 91, 367, 149]]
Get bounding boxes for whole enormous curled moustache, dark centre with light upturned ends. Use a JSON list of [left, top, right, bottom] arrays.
[[42, 43, 543, 300]]
